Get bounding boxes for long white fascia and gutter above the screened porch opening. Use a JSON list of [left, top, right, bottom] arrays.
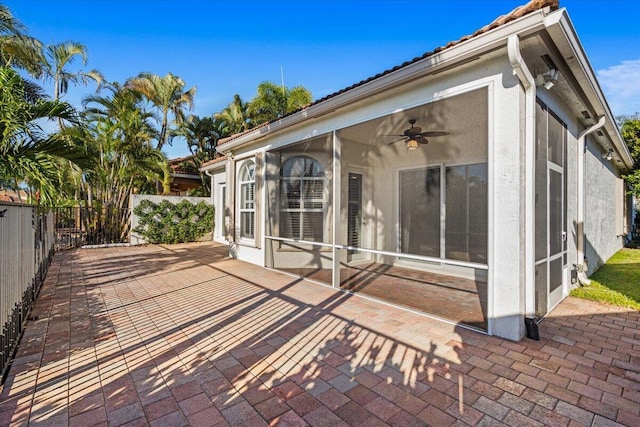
[[217, 10, 544, 152]]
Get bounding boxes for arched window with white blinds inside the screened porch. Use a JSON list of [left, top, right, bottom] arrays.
[[280, 156, 325, 242]]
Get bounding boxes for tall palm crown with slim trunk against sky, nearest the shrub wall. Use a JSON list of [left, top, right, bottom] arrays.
[[125, 73, 196, 150]]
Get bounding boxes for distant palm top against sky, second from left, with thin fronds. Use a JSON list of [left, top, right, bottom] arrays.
[[44, 41, 104, 99]]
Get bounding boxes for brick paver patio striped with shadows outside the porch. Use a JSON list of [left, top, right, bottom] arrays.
[[0, 244, 640, 426]]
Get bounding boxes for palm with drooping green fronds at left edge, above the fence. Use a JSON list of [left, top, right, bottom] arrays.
[[0, 68, 93, 205]]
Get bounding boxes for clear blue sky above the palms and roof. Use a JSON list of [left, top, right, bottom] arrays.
[[6, 0, 640, 157]]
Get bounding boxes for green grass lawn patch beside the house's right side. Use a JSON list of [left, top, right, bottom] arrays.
[[571, 248, 640, 310]]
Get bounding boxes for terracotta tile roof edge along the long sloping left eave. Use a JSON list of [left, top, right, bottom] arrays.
[[218, 0, 560, 146]]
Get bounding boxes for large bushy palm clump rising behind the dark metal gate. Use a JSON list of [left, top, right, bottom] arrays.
[[65, 83, 171, 242]]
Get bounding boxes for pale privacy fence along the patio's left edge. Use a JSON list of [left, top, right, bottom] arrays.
[[0, 202, 55, 382]]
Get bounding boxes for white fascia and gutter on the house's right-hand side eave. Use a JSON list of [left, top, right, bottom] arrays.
[[545, 9, 633, 169]]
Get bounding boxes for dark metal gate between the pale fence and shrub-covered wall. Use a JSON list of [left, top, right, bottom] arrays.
[[55, 207, 131, 250]]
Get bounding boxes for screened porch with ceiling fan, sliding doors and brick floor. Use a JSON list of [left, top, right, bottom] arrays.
[[262, 87, 489, 330]]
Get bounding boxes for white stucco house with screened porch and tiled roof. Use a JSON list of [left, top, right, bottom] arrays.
[[202, 1, 632, 340]]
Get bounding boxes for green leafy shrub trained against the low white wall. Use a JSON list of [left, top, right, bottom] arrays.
[[133, 199, 214, 244]]
